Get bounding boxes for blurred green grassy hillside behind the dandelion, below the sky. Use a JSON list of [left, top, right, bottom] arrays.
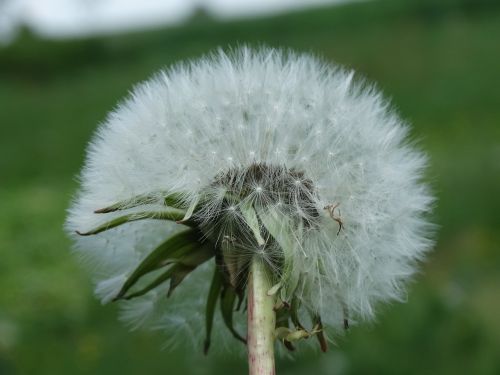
[[0, 0, 500, 375]]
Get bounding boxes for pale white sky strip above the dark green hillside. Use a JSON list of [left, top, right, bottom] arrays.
[[0, 0, 349, 43]]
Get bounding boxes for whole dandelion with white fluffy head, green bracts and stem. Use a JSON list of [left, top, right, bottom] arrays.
[[66, 48, 433, 374]]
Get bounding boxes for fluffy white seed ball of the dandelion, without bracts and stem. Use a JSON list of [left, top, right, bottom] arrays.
[[66, 47, 433, 350]]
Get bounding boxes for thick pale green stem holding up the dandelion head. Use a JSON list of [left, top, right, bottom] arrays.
[[247, 257, 276, 375]]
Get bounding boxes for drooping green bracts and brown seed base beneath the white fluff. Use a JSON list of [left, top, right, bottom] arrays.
[[78, 164, 336, 353]]
